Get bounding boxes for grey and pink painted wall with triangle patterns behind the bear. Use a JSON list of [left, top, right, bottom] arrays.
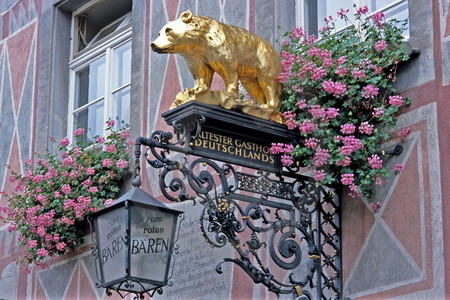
[[0, 0, 450, 300]]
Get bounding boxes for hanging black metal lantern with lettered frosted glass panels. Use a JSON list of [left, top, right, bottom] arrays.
[[92, 187, 182, 298]]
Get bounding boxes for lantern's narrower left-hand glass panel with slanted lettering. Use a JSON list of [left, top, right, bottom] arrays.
[[95, 206, 127, 284]]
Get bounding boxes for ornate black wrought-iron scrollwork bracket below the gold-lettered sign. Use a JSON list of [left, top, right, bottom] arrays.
[[135, 104, 342, 299]]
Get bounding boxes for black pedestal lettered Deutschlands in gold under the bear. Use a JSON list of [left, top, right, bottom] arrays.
[[162, 101, 299, 173]]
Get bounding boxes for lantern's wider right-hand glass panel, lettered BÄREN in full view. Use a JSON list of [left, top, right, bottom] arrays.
[[130, 205, 177, 283]]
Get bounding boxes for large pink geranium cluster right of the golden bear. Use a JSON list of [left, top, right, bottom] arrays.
[[272, 7, 410, 197]]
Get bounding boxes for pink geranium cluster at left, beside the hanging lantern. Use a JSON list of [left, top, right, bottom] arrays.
[[0, 120, 134, 265]]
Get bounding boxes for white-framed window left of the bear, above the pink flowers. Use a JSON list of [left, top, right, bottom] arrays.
[[68, 0, 132, 142]]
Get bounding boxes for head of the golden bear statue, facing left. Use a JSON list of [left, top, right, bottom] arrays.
[[151, 10, 198, 53]]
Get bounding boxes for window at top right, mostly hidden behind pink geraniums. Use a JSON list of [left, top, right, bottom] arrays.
[[296, 0, 409, 38]]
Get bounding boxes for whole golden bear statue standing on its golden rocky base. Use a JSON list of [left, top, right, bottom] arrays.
[[151, 11, 282, 123]]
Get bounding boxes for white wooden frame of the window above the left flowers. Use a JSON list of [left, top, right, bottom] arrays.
[[67, 3, 132, 138]]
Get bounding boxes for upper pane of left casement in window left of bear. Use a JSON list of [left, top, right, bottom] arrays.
[[74, 56, 105, 109]]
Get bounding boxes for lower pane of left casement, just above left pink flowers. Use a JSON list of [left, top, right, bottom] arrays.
[[74, 100, 104, 143]]
